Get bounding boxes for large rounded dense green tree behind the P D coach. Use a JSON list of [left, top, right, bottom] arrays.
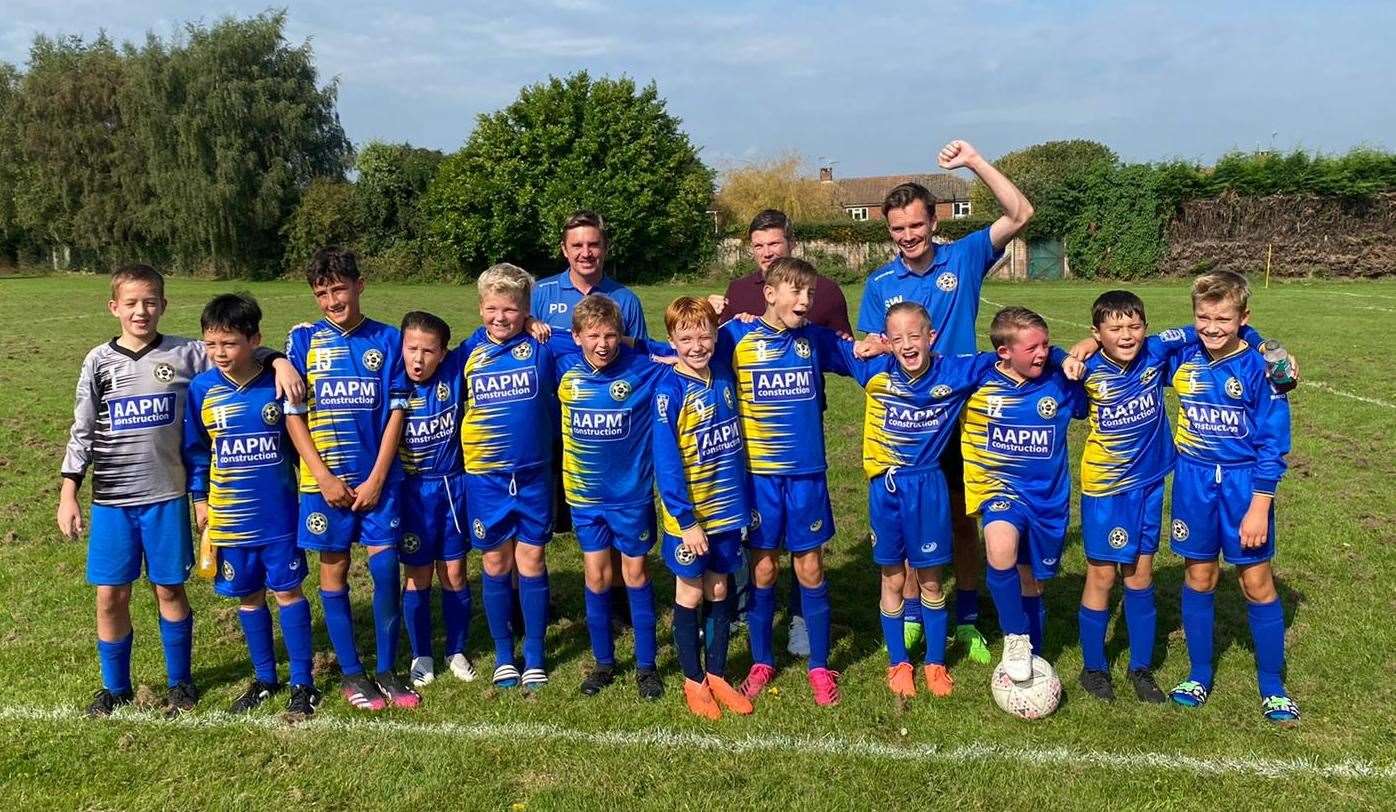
[[422, 73, 713, 279]]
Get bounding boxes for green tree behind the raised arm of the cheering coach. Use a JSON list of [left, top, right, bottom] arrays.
[[969, 141, 1118, 239]]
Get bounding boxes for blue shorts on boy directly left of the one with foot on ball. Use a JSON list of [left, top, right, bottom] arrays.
[[868, 467, 953, 569]]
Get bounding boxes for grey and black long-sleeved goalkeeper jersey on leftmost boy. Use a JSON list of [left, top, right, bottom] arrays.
[[63, 335, 208, 508]]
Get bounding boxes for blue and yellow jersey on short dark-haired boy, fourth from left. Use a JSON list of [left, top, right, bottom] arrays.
[[399, 349, 465, 476]]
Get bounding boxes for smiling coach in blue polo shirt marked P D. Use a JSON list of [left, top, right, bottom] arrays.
[[532, 211, 649, 339]]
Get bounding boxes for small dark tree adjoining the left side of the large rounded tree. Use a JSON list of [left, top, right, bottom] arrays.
[[353, 142, 445, 254]]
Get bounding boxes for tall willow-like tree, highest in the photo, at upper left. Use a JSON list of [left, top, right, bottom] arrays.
[[123, 13, 352, 272]]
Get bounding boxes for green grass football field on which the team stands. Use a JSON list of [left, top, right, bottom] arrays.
[[0, 276, 1396, 809]]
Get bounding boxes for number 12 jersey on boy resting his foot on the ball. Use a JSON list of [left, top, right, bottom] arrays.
[[960, 364, 1086, 516]]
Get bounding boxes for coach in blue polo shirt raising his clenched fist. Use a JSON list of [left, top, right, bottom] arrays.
[[859, 141, 1033, 663]]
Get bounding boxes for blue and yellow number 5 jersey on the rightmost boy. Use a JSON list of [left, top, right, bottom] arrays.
[[1171, 340, 1290, 494]]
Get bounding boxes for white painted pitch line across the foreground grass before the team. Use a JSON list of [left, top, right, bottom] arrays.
[[0, 706, 1396, 781]]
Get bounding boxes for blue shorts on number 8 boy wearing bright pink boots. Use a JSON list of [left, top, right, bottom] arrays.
[[747, 472, 833, 552]]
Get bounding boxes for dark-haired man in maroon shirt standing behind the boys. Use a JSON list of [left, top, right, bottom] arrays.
[[708, 209, 853, 657]]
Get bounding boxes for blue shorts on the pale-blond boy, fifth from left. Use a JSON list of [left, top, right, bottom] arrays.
[[465, 465, 553, 551]]
